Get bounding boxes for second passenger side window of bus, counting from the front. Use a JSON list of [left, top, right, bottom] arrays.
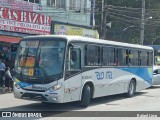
[[102, 47, 115, 66]]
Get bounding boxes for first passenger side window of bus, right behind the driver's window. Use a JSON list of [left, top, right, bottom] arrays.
[[85, 45, 100, 66]]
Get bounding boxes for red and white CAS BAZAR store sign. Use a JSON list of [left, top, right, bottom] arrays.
[[0, 8, 51, 34]]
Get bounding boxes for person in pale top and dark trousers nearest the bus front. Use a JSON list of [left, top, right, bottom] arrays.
[[3, 67, 13, 93]]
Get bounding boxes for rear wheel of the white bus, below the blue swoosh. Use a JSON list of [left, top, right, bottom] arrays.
[[127, 80, 136, 97]]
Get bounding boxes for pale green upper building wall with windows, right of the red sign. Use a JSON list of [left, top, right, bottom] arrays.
[[36, 0, 95, 26]]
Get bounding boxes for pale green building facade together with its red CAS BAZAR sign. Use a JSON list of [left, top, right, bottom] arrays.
[[0, 0, 95, 37]]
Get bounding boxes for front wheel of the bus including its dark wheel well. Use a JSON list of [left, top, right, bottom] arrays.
[[80, 82, 94, 107]]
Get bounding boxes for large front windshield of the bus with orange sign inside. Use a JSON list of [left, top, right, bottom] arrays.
[[15, 39, 66, 81]]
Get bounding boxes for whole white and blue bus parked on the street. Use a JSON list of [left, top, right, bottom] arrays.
[[14, 35, 153, 107]]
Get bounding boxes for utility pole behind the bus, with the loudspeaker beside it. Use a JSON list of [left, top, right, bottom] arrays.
[[101, 0, 107, 39]]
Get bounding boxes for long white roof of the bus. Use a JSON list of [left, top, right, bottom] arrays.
[[24, 35, 153, 50]]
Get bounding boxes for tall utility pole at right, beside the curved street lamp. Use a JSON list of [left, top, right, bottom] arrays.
[[140, 0, 145, 45]]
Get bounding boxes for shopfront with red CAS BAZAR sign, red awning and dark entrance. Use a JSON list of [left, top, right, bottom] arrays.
[[0, 6, 51, 67]]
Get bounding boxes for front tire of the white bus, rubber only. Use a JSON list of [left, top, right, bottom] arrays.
[[80, 85, 91, 107]]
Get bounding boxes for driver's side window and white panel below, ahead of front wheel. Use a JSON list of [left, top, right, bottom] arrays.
[[64, 48, 82, 102]]
